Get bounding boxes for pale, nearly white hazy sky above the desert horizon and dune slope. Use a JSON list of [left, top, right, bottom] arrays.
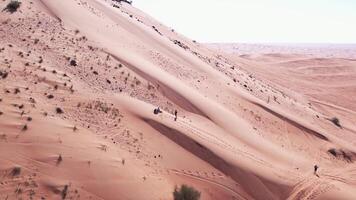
[[133, 0, 356, 43]]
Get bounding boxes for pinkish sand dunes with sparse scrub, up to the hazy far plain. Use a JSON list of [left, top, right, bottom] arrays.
[[0, 0, 356, 200]]
